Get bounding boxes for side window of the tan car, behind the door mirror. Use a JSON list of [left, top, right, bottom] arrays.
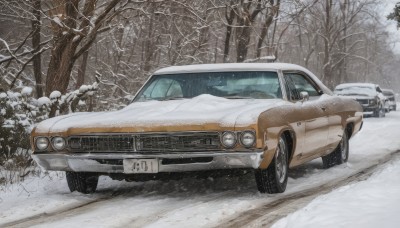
[[284, 73, 321, 101]]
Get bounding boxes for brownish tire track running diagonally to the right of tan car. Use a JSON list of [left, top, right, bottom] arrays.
[[216, 151, 400, 228]]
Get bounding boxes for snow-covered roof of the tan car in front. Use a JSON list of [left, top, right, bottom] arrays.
[[154, 63, 308, 75]]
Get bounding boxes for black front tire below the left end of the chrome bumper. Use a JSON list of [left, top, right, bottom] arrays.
[[66, 172, 99, 194]]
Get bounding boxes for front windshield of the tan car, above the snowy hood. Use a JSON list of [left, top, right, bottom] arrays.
[[134, 71, 282, 102]]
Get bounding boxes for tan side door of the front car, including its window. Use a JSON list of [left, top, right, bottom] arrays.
[[283, 72, 329, 160]]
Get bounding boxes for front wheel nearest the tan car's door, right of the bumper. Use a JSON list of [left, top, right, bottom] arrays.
[[255, 136, 289, 194]]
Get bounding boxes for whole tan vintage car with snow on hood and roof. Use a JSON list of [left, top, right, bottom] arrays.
[[31, 63, 363, 193]]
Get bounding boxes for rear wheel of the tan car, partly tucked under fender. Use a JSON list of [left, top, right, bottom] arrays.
[[322, 130, 349, 169]]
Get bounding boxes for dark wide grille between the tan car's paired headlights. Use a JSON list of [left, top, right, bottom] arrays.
[[68, 132, 220, 152]]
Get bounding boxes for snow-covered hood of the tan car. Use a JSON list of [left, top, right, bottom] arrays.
[[33, 95, 289, 135]]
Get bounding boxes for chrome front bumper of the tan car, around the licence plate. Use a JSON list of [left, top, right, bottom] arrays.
[[32, 151, 264, 173]]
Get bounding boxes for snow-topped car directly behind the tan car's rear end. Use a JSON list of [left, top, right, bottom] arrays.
[[334, 83, 388, 118]]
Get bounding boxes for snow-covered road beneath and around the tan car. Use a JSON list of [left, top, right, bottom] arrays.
[[0, 109, 400, 227]]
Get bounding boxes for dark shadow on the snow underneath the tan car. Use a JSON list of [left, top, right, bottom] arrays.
[[89, 159, 323, 197]]
